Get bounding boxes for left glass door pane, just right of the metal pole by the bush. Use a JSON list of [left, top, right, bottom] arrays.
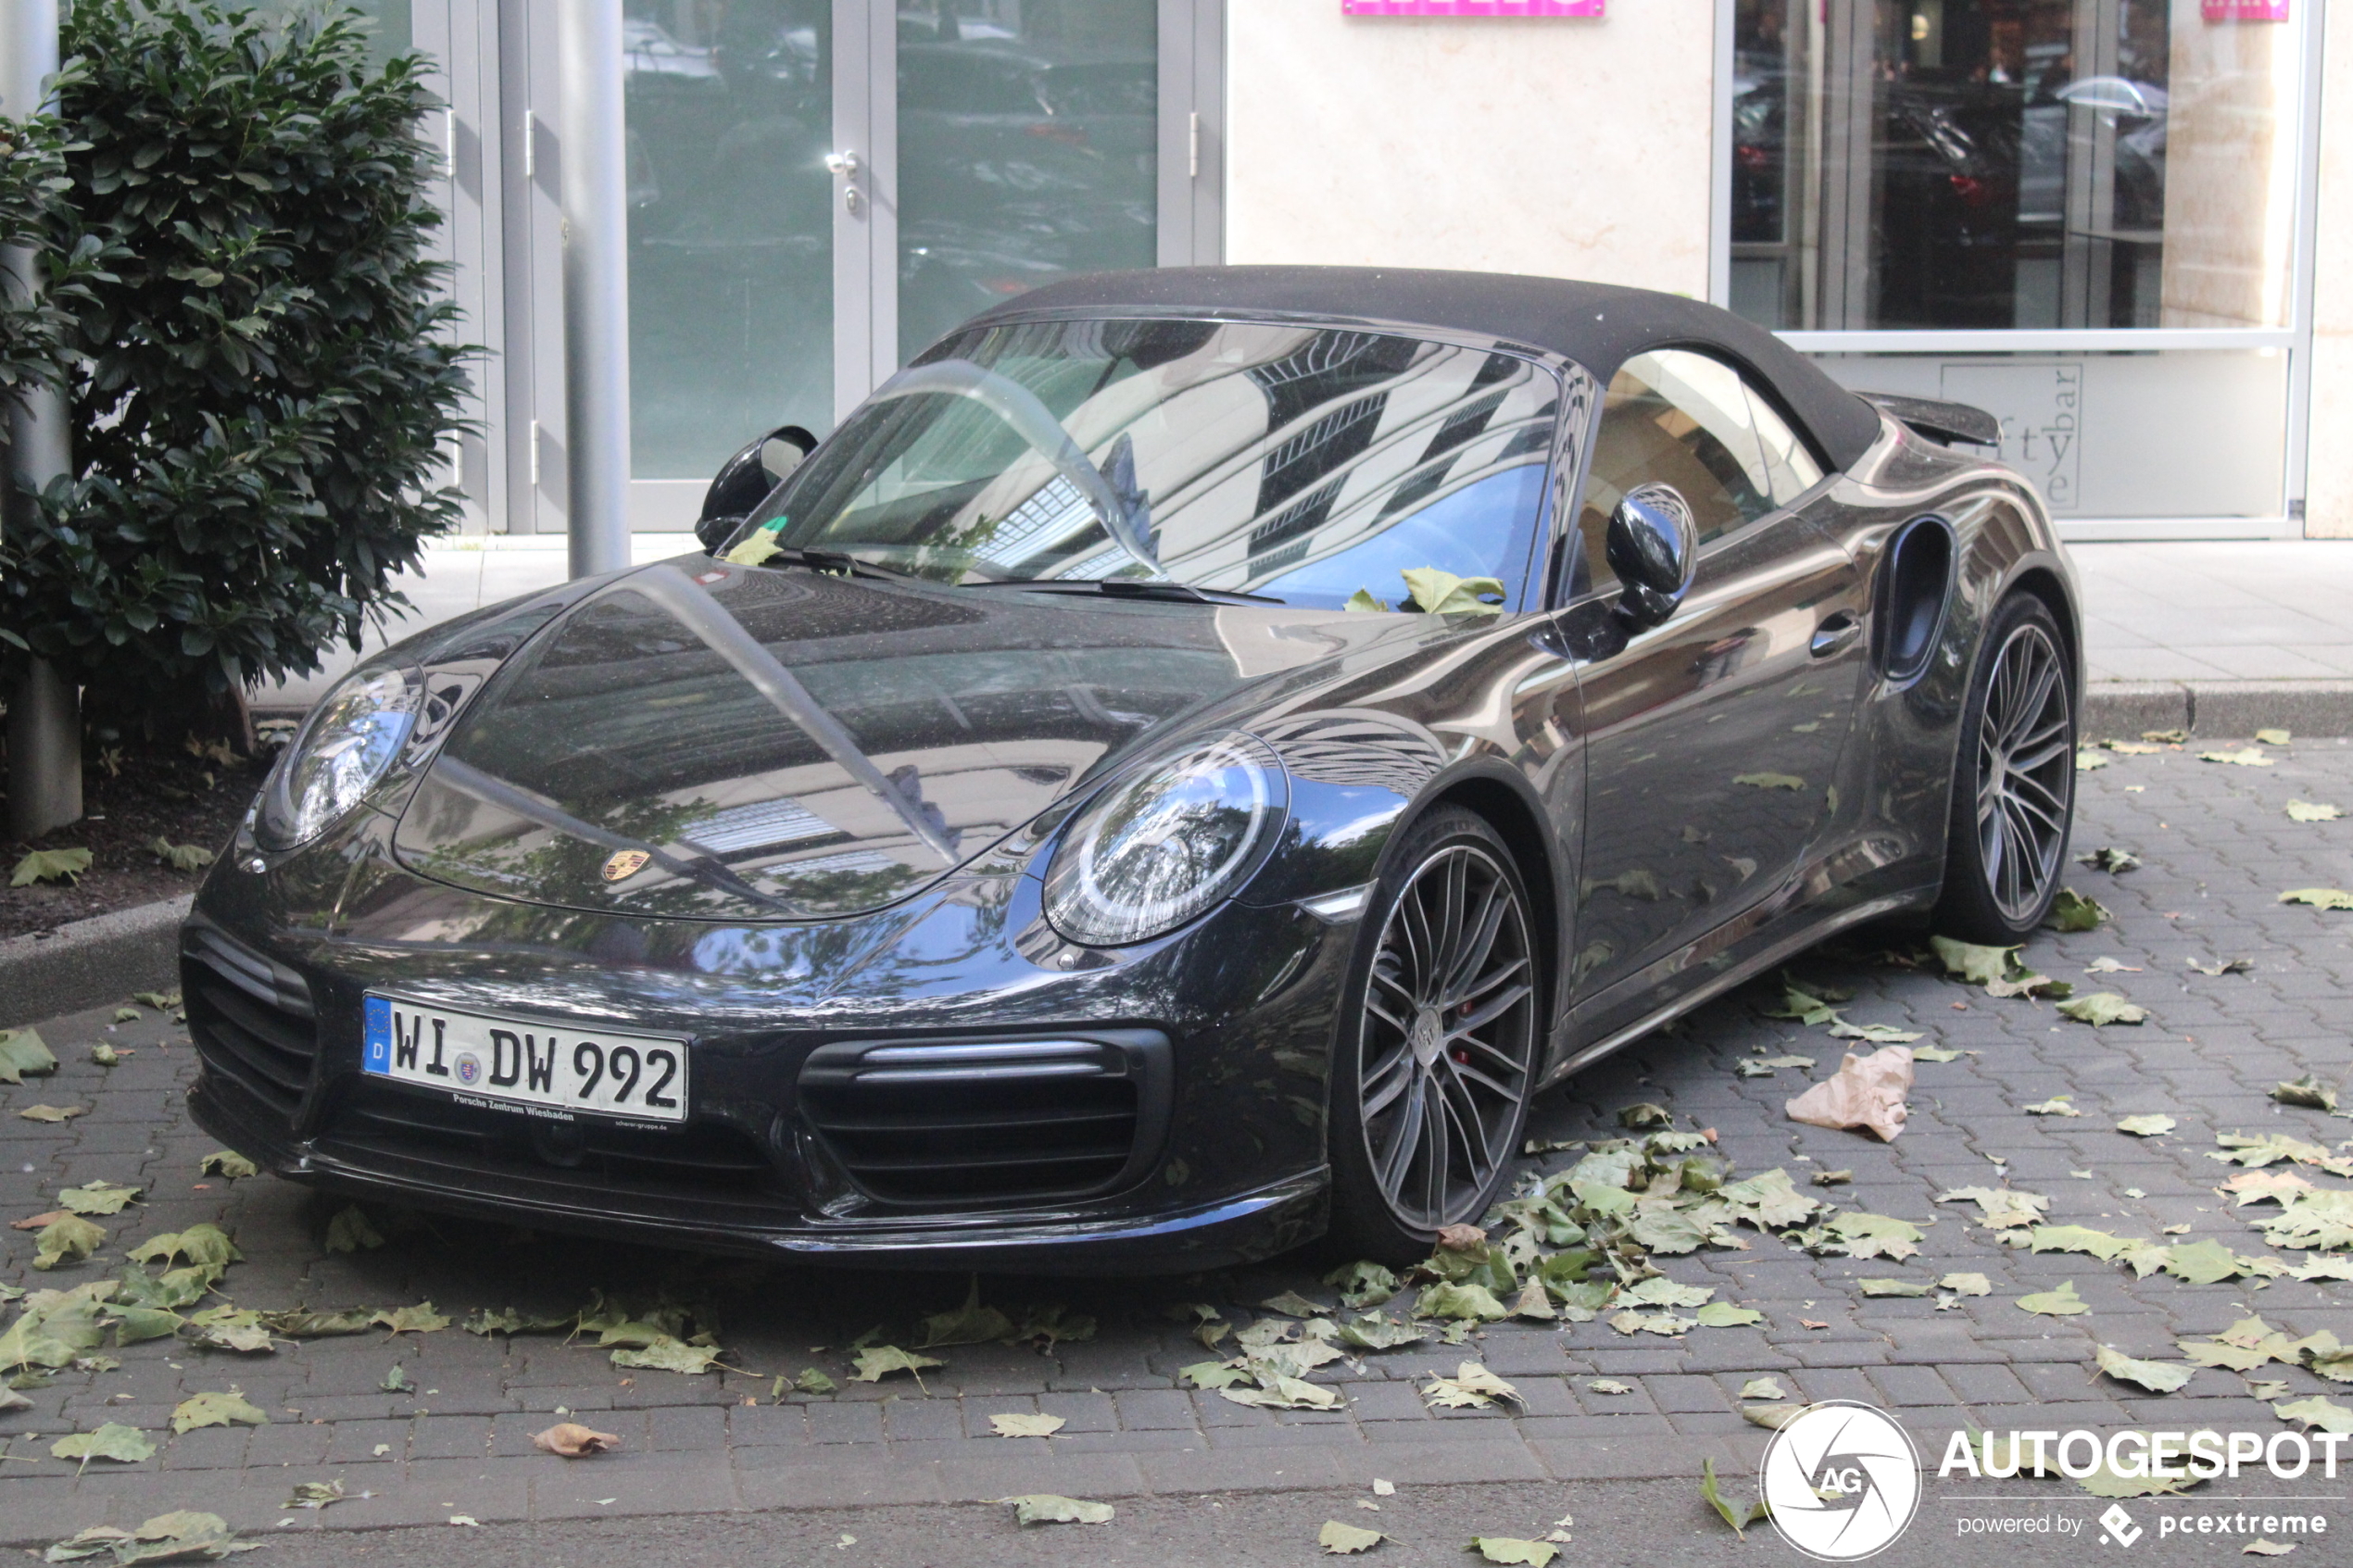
[[622, 0, 833, 480]]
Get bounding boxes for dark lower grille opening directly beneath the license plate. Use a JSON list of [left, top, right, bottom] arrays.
[[322, 1084, 776, 1194]]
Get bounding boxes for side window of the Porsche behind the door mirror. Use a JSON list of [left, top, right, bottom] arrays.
[[1579, 348, 1821, 588]]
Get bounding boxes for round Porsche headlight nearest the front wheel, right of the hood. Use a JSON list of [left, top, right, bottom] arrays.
[[1045, 734, 1290, 947]]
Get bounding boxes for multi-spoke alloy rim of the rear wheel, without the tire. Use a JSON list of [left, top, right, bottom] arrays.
[[1977, 623, 2075, 922]]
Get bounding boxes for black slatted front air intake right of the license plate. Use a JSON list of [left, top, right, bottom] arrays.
[[800, 1030, 1169, 1209]]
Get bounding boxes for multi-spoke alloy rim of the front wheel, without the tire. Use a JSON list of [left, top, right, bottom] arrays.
[[1358, 844, 1537, 1229]]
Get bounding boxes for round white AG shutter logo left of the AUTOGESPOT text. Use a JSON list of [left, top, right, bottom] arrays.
[[1757, 1399, 1920, 1563]]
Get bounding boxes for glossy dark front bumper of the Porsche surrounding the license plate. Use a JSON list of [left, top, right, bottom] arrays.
[[182, 856, 1353, 1274]]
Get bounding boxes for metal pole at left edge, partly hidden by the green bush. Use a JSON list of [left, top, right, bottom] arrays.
[[0, 0, 82, 839]]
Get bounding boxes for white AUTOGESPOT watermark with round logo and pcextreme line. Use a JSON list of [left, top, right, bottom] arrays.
[[1757, 1399, 2348, 1563]]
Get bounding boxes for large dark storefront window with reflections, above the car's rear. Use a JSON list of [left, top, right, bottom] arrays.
[[1730, 0, 2301, 332]]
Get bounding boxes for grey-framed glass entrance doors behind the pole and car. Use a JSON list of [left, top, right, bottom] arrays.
[[486, 0, 1224, 533]]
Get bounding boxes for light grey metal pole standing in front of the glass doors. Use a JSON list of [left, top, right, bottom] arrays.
[[555, 0, 628, 576]]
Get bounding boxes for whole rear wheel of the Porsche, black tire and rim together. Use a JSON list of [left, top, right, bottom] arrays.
[[1934, 593, 2075, 947]]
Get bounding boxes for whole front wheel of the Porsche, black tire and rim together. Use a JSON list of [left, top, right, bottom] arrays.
[[1329, 807, 1543, 1265]]
